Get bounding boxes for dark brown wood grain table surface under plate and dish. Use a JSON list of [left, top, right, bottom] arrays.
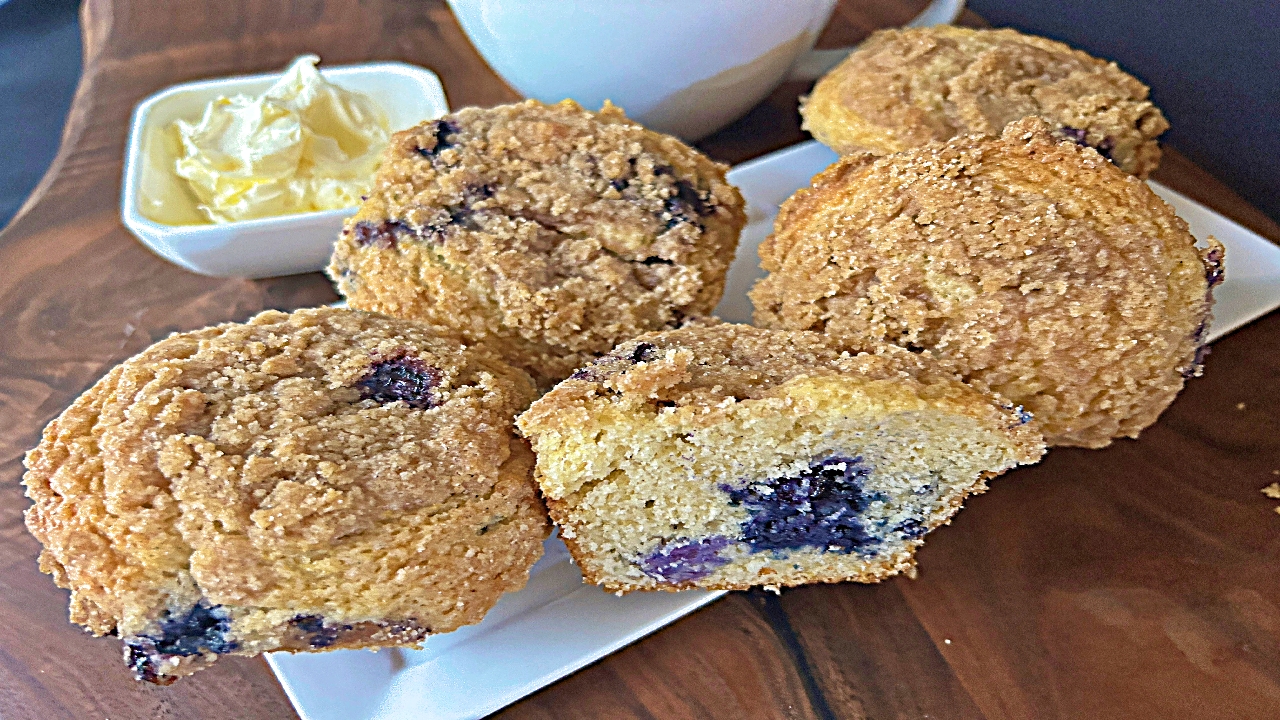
[[0, 0, 1280, 720]]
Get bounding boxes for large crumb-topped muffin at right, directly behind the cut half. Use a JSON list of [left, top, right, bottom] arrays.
[[750, 118, 1222, 447]]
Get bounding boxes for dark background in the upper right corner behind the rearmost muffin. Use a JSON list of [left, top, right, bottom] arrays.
[[969, 0, 1280, 222]]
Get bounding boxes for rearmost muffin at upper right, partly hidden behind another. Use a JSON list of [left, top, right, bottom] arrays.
[[800, 26, 1169, 178]]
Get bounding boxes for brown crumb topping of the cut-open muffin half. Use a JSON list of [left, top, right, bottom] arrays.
[[518, 318, 1038, 437]]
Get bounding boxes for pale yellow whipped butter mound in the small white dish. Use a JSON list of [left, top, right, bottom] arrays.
[[173, 55, 390, 223]]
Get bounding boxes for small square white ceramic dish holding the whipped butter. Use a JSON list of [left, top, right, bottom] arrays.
[[120, 63, 449, 278]]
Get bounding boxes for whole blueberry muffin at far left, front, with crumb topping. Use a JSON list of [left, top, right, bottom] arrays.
[[24, 309, 549, 684]]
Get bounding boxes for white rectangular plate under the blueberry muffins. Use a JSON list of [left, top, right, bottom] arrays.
[[268, 137, 1280, 720]]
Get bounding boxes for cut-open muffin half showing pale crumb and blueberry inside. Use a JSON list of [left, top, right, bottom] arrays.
[[517, 324, 1044, 592]]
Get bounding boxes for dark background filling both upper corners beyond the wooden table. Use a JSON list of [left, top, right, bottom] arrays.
[[0, 0, 1280, 227]]
